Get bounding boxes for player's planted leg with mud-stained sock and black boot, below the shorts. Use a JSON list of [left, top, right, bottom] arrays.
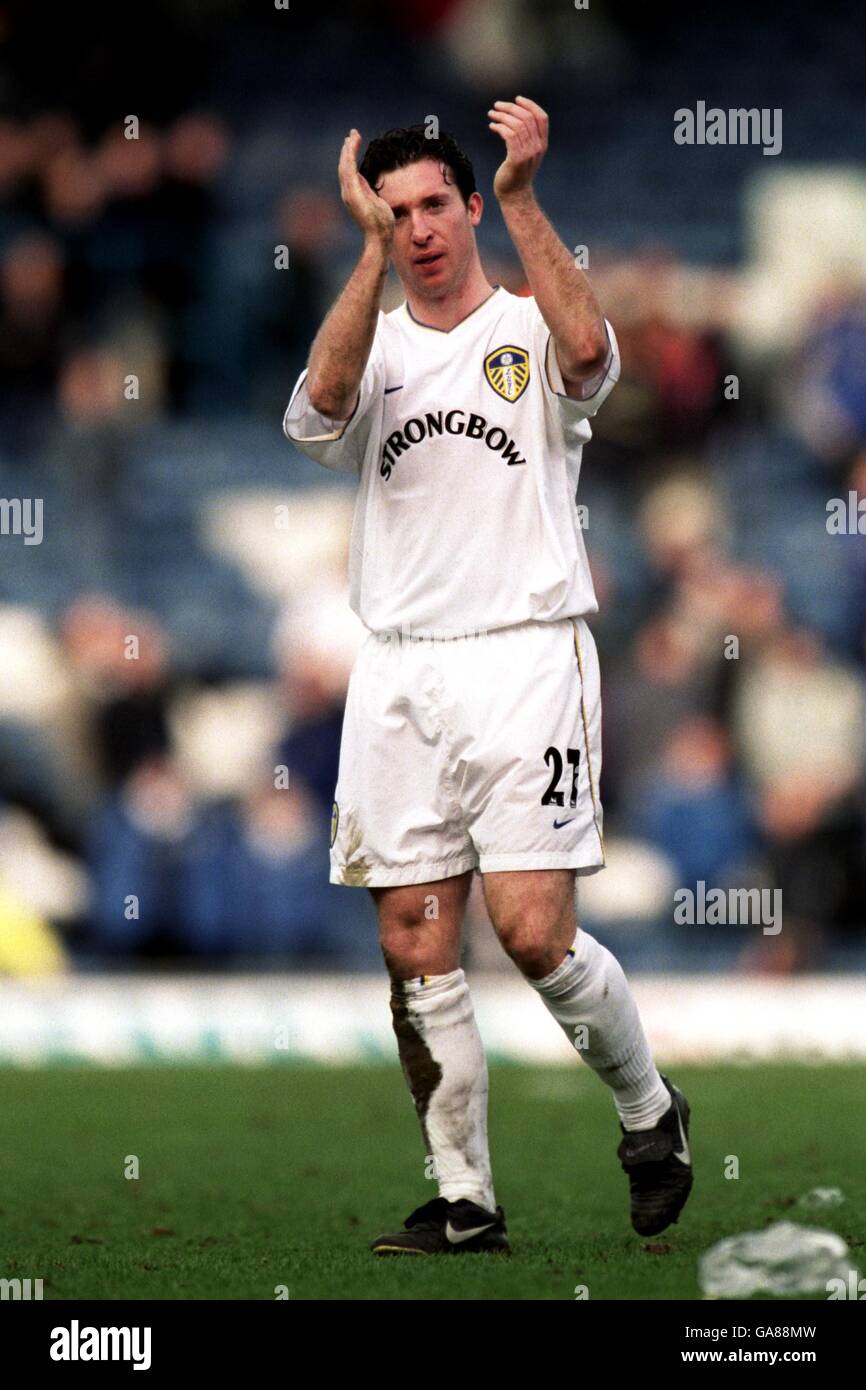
[[370, 872, 507, 1255]]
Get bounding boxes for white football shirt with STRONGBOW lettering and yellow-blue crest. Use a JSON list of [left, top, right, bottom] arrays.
[[284, 296, 620, 639]]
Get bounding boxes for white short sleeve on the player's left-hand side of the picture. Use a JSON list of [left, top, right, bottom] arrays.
[[282, 322, 385, 473]]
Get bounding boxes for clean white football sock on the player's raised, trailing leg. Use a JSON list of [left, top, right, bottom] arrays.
[[528, 930, 671, 1130]]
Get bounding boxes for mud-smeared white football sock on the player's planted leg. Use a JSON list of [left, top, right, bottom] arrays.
[[391, 970, 496, 1211]]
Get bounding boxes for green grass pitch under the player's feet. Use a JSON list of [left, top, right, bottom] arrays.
[[0, 1065, 866, 1300]]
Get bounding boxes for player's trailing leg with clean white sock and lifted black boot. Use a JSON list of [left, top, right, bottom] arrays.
[[482, 869, 692, 1236]]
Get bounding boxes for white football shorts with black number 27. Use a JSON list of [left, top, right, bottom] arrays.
[[329, 617, 605, 888]]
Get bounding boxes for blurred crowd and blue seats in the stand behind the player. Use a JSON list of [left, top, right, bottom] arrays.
[[0, 6, 866, 973]]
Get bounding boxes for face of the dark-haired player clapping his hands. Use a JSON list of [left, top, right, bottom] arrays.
[[377, 160, 484, 299]]
